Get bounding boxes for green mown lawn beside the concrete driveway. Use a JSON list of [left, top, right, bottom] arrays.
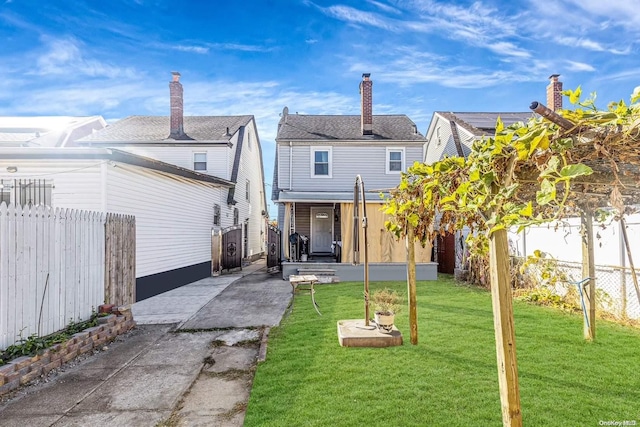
[[245, 276, 640, 427]]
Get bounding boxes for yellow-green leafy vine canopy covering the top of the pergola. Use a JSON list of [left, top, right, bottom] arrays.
[[385, 87, 640, 253]]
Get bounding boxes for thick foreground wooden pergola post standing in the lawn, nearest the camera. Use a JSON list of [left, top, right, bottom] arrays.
[[489, 229, 522, 427]]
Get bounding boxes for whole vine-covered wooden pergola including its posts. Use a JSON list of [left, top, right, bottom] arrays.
[[385, 87, 640, 426]]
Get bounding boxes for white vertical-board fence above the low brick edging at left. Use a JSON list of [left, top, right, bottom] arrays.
[[0, 203, 105, 349]]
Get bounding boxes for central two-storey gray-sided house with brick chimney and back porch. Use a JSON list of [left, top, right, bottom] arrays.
[[272, 74, 431, 277]]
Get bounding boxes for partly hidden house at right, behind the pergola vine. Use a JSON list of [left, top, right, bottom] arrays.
[[424, 74, 562, 273]]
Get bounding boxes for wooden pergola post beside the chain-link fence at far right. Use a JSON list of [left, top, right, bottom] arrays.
[[578, 207, 596, 341]]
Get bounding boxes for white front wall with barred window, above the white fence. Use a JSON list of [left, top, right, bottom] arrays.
[[0, 159, 106, 211]]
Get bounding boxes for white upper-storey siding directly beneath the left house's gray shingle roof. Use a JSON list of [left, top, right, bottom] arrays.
[[114, 146, 235, 179]]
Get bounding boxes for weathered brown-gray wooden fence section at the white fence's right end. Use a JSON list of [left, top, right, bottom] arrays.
[[104, 213, 136, 305]]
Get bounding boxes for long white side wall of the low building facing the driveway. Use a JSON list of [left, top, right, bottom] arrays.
[[107, 164, 227, 277]]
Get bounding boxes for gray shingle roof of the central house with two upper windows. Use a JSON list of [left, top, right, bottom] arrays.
[[276, 114, 424, 141]]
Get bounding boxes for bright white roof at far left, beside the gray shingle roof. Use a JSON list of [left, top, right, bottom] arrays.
[[0, 116, 107, 147]]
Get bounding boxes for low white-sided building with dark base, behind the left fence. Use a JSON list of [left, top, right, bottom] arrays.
[[0, 147, 234, 300]]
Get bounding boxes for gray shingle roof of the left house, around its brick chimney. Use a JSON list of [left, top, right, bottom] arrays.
[[79, 115, 253, 144]]
